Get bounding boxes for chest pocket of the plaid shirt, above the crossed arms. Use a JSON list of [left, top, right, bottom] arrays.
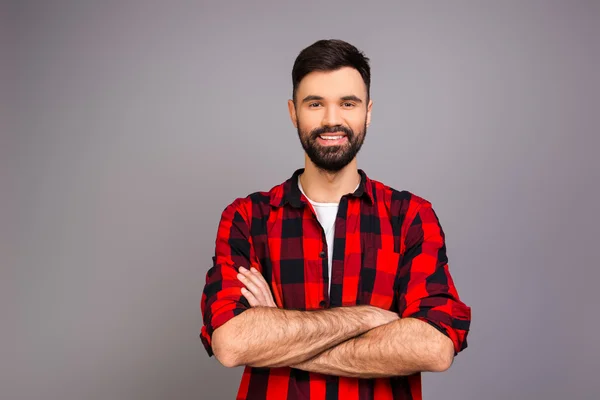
[[357, 247, 400, 310]]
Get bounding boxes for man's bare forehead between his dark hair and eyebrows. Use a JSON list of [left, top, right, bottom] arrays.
[[296, 67, 367, 98]]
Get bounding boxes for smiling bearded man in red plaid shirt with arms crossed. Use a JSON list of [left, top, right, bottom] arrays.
[[201, 40, 471, 400]]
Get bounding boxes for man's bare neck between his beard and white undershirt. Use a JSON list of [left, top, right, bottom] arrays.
[[299, 156, 360, 203]]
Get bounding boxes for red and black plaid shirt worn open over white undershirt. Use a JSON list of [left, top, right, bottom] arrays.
[[200, 169, 471, 400]]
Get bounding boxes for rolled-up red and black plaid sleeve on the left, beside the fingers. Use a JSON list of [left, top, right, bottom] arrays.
[[200, 199, 253, 357]]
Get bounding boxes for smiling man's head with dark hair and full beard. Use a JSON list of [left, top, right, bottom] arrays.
[[288, 40, 373, 172]]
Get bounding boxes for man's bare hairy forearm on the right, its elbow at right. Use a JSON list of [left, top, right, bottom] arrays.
[[291, 318, 454, 378]]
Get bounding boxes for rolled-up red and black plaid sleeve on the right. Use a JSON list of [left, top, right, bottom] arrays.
[[396, 201, 471, 355]]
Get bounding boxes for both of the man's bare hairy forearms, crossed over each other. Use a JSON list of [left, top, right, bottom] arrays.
[[212, 292, 454, 378]]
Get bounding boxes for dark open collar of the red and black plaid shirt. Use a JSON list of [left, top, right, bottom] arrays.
[[270, 168, 375, 208]]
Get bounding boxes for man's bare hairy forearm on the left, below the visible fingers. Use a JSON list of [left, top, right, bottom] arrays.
[[214, 306, 381, 367]]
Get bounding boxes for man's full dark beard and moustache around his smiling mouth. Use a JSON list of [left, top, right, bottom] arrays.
[[297, 118, 367, 172]]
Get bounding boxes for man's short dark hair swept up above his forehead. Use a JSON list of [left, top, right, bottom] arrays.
[[292, 39, 371, 102]]
